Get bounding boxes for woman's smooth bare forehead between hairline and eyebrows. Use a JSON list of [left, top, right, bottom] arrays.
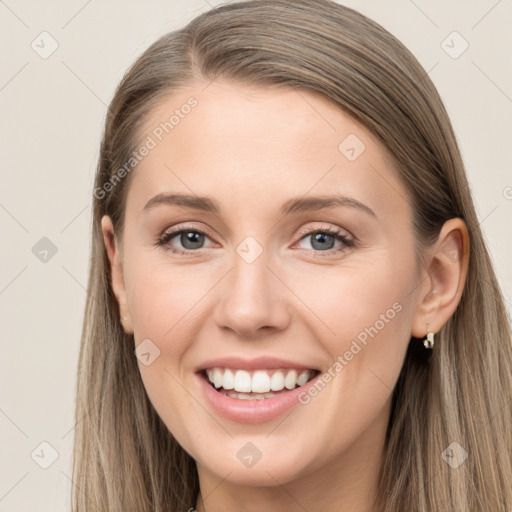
[[127, 82, 409, 221]]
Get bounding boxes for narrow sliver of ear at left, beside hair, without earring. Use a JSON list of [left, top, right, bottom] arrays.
[[101, 215, 133, 334]]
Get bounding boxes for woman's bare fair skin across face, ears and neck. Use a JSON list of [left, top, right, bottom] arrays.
[[102, 81, 468, 512]]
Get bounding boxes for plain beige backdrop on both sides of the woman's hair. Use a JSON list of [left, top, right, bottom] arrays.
[[0, 0, 512, 512]]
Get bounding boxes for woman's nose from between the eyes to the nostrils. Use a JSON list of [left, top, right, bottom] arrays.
[[214, 247, 290, 337]]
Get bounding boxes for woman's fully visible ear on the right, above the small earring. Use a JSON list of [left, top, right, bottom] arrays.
[[411, 218, 469, 338]]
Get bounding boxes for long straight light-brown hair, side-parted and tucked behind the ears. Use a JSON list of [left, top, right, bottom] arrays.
[[72, 0, 512, 512]]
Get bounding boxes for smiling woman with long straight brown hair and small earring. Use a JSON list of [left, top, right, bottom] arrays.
[[73, 0, 512, 512]]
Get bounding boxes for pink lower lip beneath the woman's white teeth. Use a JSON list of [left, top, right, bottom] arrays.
[[196, 373, 321, 423]]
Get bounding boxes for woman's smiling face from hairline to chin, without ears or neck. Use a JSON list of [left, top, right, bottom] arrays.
[[105, 81, 421, 485]]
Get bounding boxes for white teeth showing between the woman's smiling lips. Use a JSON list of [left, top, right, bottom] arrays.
[[199, 367, 320, 400]]
